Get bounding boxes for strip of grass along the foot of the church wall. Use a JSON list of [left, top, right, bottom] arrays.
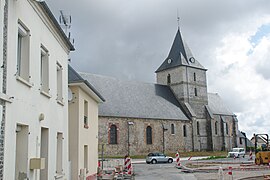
[[99, 151, 227, 159]]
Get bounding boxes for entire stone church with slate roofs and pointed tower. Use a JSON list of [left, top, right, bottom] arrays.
[[80, 28, 239, 156]]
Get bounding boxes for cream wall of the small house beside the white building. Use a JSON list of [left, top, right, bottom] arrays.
[[69, 86, 98, 179]]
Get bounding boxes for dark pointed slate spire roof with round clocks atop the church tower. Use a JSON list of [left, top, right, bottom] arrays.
[[156, 29, 206, 72]]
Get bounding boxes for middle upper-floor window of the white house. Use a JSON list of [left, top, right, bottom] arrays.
[[40, 45, 49, 93]]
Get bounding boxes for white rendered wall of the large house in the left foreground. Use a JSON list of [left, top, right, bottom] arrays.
[[4, 0, 69, 179]]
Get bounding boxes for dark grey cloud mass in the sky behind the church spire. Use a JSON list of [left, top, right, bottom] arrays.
[[46, 0, 270, 138]]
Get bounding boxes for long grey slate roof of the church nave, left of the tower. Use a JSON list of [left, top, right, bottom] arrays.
[[79, 73, 188, 120]]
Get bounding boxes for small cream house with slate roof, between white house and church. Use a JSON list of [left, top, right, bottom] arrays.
[[68, 66, 104, 180]]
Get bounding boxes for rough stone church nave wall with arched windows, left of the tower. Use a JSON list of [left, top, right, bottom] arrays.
[[98, 117, 192, 156]]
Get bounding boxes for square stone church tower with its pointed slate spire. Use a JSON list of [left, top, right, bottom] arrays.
[[156, 28, 208, 118]]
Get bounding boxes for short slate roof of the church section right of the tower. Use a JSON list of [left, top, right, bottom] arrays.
[[208, 93, 234, 116]]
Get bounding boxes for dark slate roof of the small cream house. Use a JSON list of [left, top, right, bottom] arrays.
[[68, 65, 105, 101]]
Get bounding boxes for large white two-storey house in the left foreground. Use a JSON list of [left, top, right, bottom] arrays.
[[3, 0, 74, 180]]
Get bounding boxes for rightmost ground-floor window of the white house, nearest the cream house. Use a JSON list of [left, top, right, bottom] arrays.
[[56, 133, 63, 174]]
